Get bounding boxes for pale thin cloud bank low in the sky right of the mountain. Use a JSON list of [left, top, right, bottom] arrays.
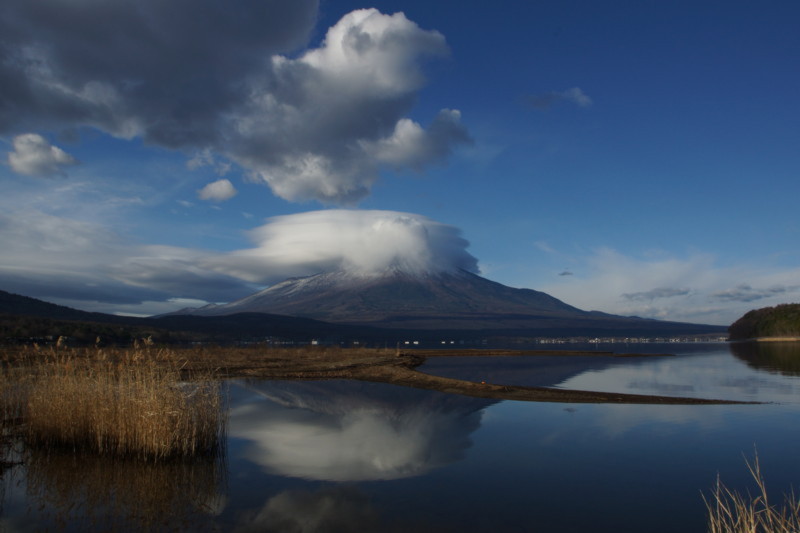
[[536, 248, 800, 325]]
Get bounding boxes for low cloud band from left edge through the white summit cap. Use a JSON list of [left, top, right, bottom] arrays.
[[0, 209, 478, 314]]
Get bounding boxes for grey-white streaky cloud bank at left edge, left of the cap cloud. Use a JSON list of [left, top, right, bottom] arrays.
[[0, 209, 256, 308]]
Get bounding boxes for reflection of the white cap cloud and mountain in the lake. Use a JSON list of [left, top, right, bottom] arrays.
[[229, 382, 495, 481]]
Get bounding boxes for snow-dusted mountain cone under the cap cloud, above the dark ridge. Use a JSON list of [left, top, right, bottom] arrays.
[[173, 270, 722, 335]]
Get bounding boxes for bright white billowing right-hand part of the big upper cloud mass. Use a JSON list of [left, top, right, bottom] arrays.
[[228, 9, 469, 203]]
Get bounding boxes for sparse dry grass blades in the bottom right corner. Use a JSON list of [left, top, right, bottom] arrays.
[[703, 454, 800, 533]]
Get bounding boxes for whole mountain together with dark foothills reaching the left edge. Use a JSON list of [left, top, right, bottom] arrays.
[[0, 284, 725, 345]]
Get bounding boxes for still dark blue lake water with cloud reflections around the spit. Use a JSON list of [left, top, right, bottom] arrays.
[[0, 344, 800, 532]]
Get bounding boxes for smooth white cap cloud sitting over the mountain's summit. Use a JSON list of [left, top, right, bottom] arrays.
[[216, 209, 478, 283]]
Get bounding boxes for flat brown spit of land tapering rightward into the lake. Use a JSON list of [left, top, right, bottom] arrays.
[[5, 345, 754, 405]]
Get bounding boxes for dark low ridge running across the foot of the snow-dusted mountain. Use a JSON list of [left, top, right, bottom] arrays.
[[0, 282, 725, 344]]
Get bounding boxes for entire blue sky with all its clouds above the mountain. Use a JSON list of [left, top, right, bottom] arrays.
[[0, 0, 800, 324]]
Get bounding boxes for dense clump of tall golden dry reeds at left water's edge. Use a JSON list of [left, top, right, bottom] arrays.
[[3, 346, 226, 460]]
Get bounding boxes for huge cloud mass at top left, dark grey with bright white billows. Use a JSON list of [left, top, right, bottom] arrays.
[[0, 0, 469, 204]]
